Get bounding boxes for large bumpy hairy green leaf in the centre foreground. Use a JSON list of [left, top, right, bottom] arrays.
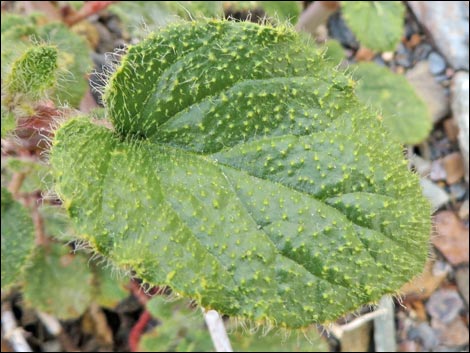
[[51, 21, 430, 328]]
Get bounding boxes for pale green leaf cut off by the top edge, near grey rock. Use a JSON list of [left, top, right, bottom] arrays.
[[341, 1, 405, 51]]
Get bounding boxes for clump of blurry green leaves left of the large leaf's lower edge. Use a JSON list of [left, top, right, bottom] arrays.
[[1, 164, 128, 319]]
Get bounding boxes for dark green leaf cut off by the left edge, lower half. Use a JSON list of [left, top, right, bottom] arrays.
[[1, 187, 34, 291]]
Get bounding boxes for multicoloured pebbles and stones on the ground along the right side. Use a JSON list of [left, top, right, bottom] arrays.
[[328, 1, 469, 352]]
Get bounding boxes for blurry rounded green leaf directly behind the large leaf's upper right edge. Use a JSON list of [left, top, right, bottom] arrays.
[[352, 63, 432, 144]]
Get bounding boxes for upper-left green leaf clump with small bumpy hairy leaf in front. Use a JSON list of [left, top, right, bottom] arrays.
[[1, 14, 91, 110]]
